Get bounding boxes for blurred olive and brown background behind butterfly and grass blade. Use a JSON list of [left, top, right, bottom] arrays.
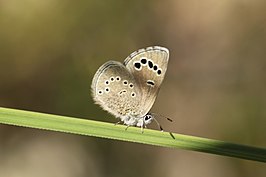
[[0, 0, 266, 177]]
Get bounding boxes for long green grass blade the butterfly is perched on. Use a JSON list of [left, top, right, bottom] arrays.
[[0, 107, 266, 162]]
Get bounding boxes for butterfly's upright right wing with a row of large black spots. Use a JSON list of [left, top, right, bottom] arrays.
[[124, 46, 169, 116]]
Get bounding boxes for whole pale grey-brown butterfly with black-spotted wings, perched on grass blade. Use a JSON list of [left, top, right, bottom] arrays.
[[91, 46, 169, 127]]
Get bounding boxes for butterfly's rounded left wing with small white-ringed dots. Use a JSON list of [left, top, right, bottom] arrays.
[[91, 61, 142, 121]]
